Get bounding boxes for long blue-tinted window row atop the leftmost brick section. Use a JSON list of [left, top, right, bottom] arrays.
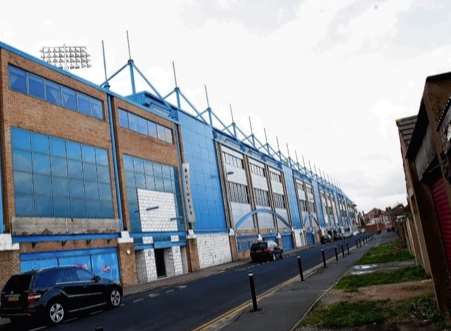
[[8, 65, 103, 120]]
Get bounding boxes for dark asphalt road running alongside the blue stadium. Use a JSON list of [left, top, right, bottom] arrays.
[[1, 233, 370, 331]]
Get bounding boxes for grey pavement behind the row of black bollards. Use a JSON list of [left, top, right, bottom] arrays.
[[213, 234, 394, 331]]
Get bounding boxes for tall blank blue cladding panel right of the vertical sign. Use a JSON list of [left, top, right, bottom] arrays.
[[179, 112, 227, 232]]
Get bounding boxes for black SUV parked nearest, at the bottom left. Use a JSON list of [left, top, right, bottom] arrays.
[[0, 267, 122, 324]]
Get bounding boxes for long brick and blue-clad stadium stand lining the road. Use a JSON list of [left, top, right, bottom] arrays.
[[0, 43, 357, 286]]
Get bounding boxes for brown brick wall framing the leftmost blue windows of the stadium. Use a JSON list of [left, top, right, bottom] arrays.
[[0, 49, 117, 231]]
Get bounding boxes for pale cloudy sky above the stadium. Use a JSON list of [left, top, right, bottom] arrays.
[[0, 0, 451, 211]]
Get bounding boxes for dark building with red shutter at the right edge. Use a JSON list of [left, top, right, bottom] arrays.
[[397, 73, 451, 314]]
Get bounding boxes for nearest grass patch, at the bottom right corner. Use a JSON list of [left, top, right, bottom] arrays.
[[301, 296, 447, 329]]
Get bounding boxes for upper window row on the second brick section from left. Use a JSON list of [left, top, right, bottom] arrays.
[[119, 109, 173, 144]]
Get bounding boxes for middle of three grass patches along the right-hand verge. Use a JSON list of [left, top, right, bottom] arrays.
[[335, 266, 428, 291]]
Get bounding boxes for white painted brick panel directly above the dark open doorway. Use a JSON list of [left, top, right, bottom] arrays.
[[138, 189, 177, 231]]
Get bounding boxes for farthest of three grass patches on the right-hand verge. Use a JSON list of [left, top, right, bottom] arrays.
[[357, 240, 413, 264]]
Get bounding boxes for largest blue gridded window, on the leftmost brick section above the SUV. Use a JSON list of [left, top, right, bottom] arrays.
[[11, 128, 114, 218]]
